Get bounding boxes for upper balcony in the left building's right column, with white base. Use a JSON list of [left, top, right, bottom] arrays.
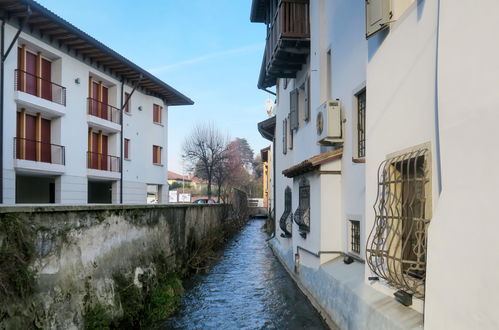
[[87, 97, 121, 133]]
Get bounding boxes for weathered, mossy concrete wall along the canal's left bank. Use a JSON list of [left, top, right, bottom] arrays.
[[0, 204, 234, 329]]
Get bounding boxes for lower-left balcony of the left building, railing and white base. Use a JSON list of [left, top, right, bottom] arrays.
[[14, 137, 66, 174]]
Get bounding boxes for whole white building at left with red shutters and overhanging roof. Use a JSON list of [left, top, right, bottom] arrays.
[[0, 0, 193, 205]]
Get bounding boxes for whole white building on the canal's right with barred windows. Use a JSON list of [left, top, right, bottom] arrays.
[[258, 0, 499, 329]]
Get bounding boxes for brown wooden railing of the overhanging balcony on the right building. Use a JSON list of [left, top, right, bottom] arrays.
[[265, 0, 310, 69]]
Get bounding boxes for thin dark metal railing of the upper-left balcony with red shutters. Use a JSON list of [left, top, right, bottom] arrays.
[[14, 69, 66, 106]]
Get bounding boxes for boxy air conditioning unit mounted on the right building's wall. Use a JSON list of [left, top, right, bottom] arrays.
[[315, 100, 343, 145]]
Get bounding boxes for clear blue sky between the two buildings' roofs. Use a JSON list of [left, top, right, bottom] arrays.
[[38, 0, 276, 172]]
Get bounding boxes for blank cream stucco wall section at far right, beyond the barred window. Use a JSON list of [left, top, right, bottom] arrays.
[[425, 0, 499, 329]]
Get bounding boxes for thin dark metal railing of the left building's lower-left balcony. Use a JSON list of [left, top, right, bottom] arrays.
[[14, 137, 66, 165]]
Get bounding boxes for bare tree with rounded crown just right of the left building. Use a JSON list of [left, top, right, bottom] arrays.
[[182, 124, 228, 198]]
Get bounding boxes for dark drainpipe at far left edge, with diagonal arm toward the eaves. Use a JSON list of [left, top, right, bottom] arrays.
[[0, 5, 31, 204]]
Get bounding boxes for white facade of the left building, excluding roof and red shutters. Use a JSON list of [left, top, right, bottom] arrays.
[[2, 1, 189, 205]]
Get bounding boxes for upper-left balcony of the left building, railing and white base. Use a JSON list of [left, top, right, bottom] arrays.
[[14, 69, 66, 117]]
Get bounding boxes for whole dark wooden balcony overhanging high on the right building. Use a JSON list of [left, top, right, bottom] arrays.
[[258, 0, 310, 88]]
